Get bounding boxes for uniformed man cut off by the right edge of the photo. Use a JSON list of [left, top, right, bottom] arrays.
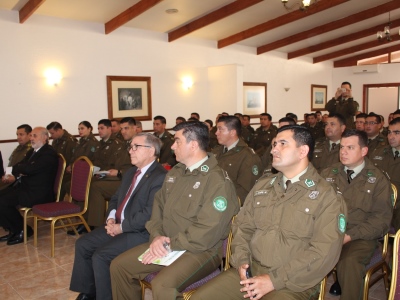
[[371, 118, 400, 231]]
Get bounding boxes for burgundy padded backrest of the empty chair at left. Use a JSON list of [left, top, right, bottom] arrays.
[[70, 156, 93, 205]]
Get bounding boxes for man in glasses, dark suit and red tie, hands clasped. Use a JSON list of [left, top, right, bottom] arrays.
[[70, 133, 167, 300]]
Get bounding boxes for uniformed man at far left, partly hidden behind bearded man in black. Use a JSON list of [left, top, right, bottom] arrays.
[[0, 124, 32, 190]]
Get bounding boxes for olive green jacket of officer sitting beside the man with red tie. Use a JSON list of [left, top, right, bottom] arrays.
[[146, 153, 239, 253]]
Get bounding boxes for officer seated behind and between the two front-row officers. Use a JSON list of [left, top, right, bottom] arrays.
[[212, 116, 262, 205]]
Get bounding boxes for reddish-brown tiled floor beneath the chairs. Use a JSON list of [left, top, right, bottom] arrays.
[[0, 222, 386, 300]]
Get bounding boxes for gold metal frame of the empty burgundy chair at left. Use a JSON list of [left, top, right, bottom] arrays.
[[33, 156, 93, 257]]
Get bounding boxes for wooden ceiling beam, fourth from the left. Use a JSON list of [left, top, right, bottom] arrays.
[[218, 0, 349, 48]]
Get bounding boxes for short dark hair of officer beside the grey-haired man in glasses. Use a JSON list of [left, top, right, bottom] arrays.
[[172, 121, 210, 151]]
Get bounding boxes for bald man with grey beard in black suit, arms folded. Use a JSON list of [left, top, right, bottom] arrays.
[[0, 127, 58, 245]]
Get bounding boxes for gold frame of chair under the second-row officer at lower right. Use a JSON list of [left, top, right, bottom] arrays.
[[363, 183, 397, 300]]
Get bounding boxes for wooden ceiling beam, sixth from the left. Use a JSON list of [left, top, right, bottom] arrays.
[[288, 19, 400, 59]]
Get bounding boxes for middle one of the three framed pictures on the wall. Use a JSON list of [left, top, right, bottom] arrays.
[[243, 82, 267, 118]]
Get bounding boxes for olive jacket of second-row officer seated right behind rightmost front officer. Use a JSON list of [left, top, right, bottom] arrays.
[[321, 158, 393, 241]]
